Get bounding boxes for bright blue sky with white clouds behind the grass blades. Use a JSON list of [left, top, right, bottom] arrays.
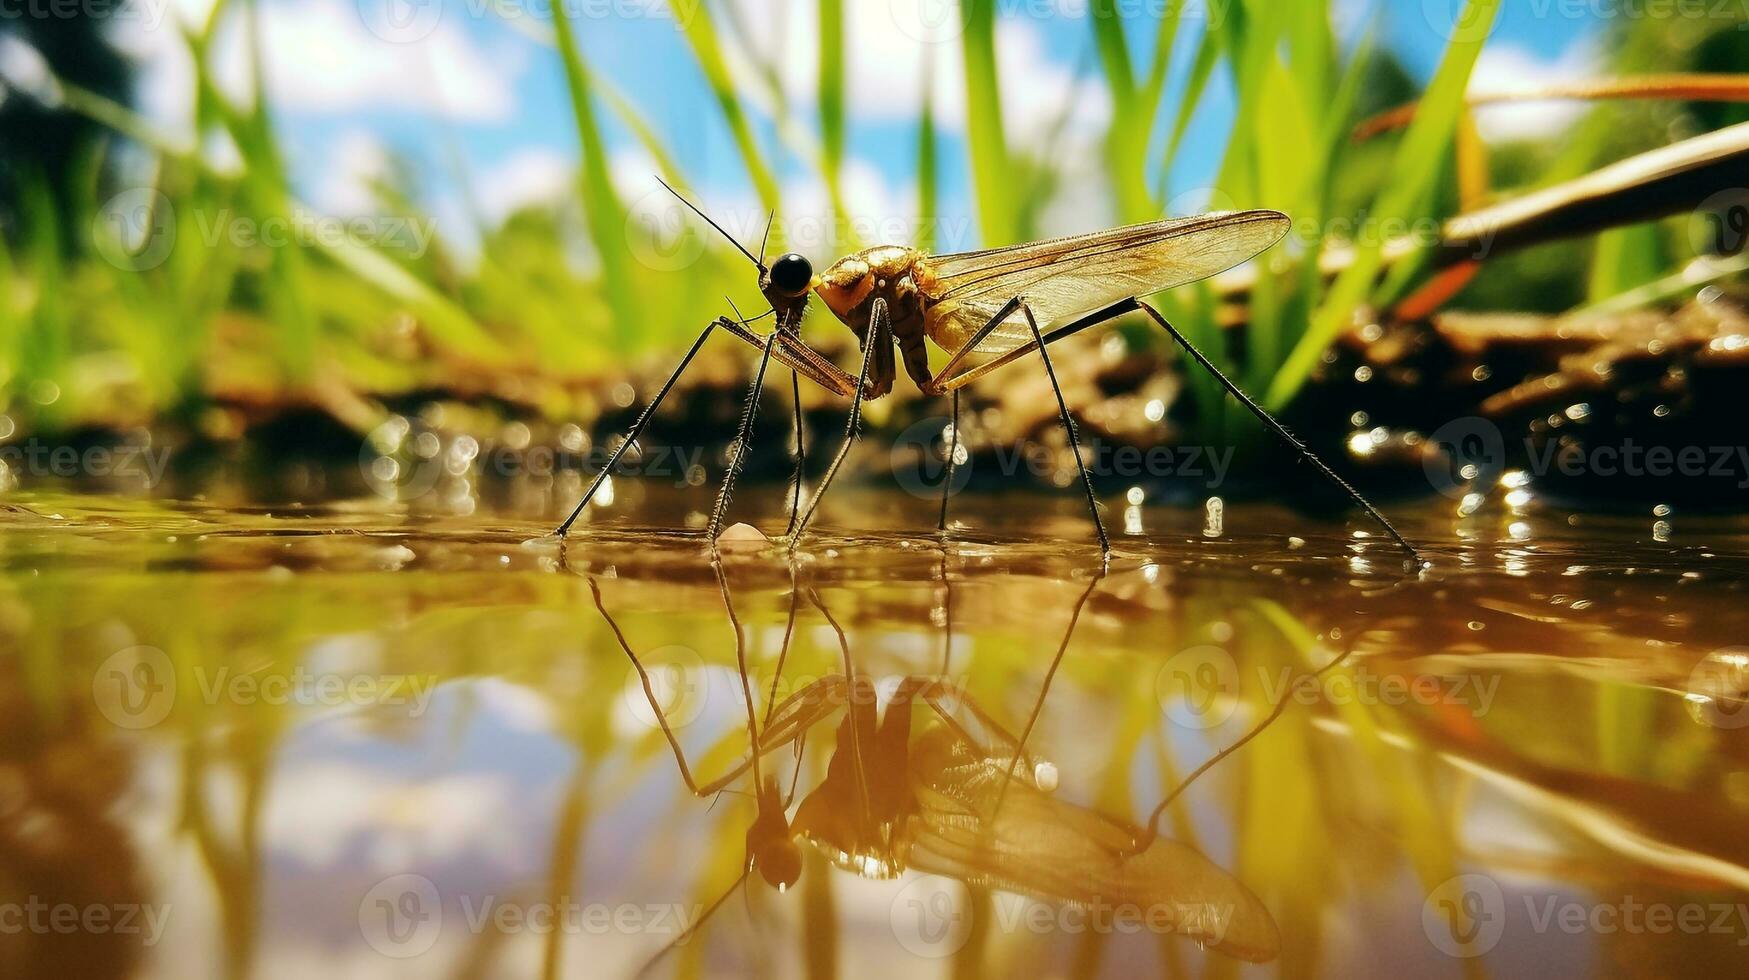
[[119, 0, 1597, 252]]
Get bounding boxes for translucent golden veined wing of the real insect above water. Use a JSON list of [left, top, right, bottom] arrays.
[[923, 210, 1289, 354]]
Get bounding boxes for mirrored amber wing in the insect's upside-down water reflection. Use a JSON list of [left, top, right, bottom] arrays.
[[904, 728, 1282, 963]]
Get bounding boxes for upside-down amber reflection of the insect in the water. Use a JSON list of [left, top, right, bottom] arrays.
[[589, 579, 1280, 963]]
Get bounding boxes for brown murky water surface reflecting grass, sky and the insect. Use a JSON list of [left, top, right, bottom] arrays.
[[0, 492, 1749, 978]]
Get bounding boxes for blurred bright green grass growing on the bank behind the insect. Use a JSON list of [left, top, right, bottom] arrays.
[[0, 0, 1725, 441]]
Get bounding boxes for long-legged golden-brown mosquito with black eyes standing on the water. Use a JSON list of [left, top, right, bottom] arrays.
[[556, 177, 1422, 567]]
